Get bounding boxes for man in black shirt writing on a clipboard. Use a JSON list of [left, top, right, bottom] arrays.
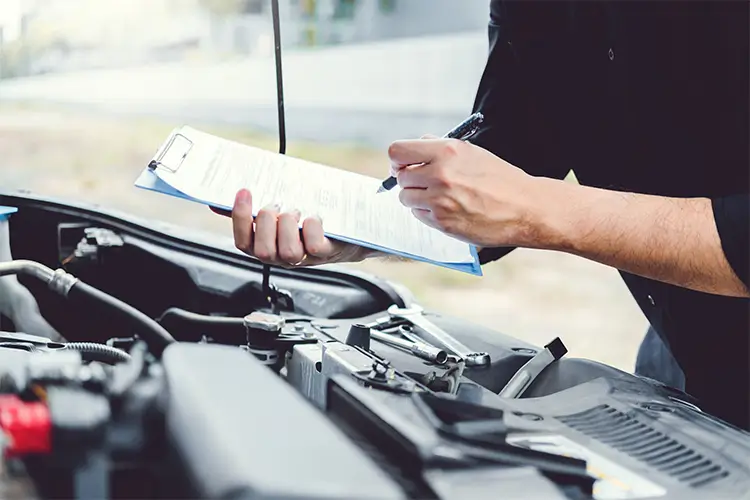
[[223, 0, 750, 429]]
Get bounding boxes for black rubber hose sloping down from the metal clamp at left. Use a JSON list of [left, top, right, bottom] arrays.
[[68, 281, 175, 357]]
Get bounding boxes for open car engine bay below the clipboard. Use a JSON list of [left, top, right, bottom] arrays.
[[0, 194, 750, 499]]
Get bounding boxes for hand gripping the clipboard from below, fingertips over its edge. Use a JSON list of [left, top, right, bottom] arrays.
[[214, 189, 379, 268]]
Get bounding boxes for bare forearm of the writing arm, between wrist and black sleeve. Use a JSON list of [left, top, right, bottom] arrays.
[[540, 179, 750, 297]]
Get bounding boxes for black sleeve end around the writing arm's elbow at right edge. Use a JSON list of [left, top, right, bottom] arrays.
[[711, 193, 750, 288]]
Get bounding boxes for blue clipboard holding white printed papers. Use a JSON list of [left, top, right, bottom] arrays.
[[135, 127, 482, 276]]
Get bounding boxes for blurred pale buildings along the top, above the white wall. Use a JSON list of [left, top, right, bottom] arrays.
[[0, 0, 489, 75]]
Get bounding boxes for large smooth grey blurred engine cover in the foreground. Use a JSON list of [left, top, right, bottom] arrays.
[[162, 343, 405, 499]]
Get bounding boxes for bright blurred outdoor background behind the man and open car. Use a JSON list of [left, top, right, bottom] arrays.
[[0, 0, 647, 371]]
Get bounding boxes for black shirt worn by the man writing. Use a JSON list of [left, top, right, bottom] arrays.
[[472, 0, 750, 428]]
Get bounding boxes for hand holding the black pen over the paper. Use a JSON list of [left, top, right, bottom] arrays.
[[388, 138, 551, 248]]
